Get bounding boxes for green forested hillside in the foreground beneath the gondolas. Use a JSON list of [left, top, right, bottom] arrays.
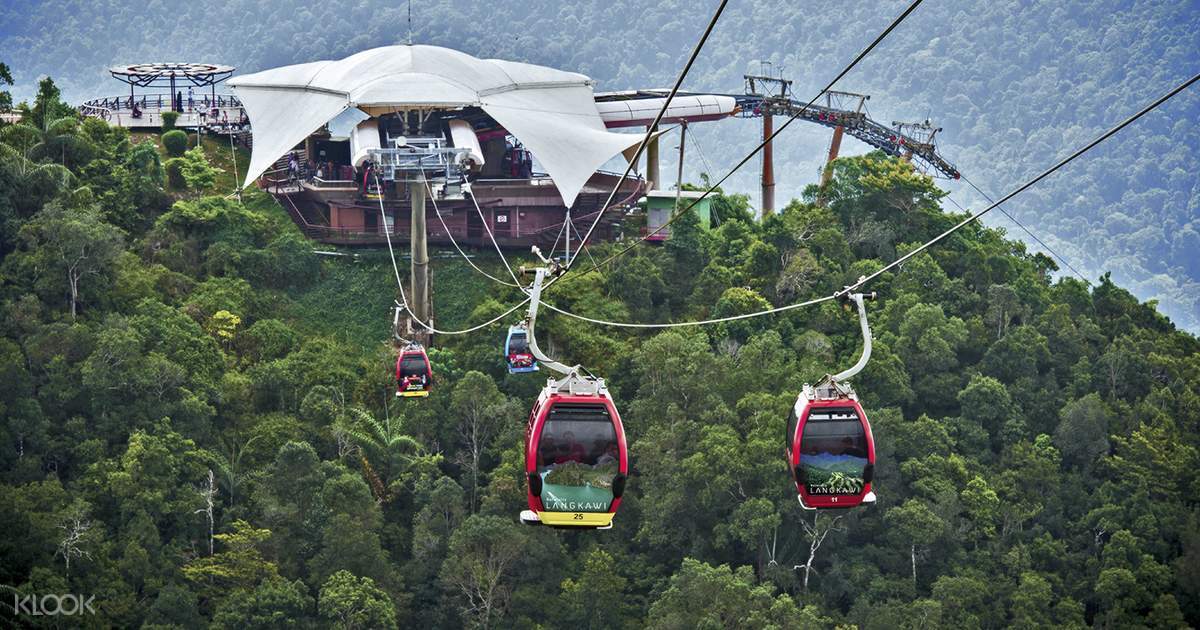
[[0, 71, 1200, 629]]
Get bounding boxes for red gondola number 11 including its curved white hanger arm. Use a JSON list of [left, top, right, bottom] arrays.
[[785, 294, 876, 510]]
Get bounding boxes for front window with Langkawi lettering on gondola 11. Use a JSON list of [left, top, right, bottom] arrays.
[[800, 408, 868, 494]]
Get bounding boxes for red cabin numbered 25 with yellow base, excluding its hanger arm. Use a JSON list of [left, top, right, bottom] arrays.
[[522, 380, 629, 528]]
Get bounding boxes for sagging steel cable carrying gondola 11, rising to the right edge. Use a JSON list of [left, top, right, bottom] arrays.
[[508, 74, 1200, 329]]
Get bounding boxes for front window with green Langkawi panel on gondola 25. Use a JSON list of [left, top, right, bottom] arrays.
[[538, 404, 620, 512]]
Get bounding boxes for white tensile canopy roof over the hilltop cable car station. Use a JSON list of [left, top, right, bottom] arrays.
[[228, 46, 641, 206]]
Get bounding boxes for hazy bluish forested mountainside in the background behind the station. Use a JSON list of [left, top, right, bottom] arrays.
[[0, 0, 1200, 332]]
